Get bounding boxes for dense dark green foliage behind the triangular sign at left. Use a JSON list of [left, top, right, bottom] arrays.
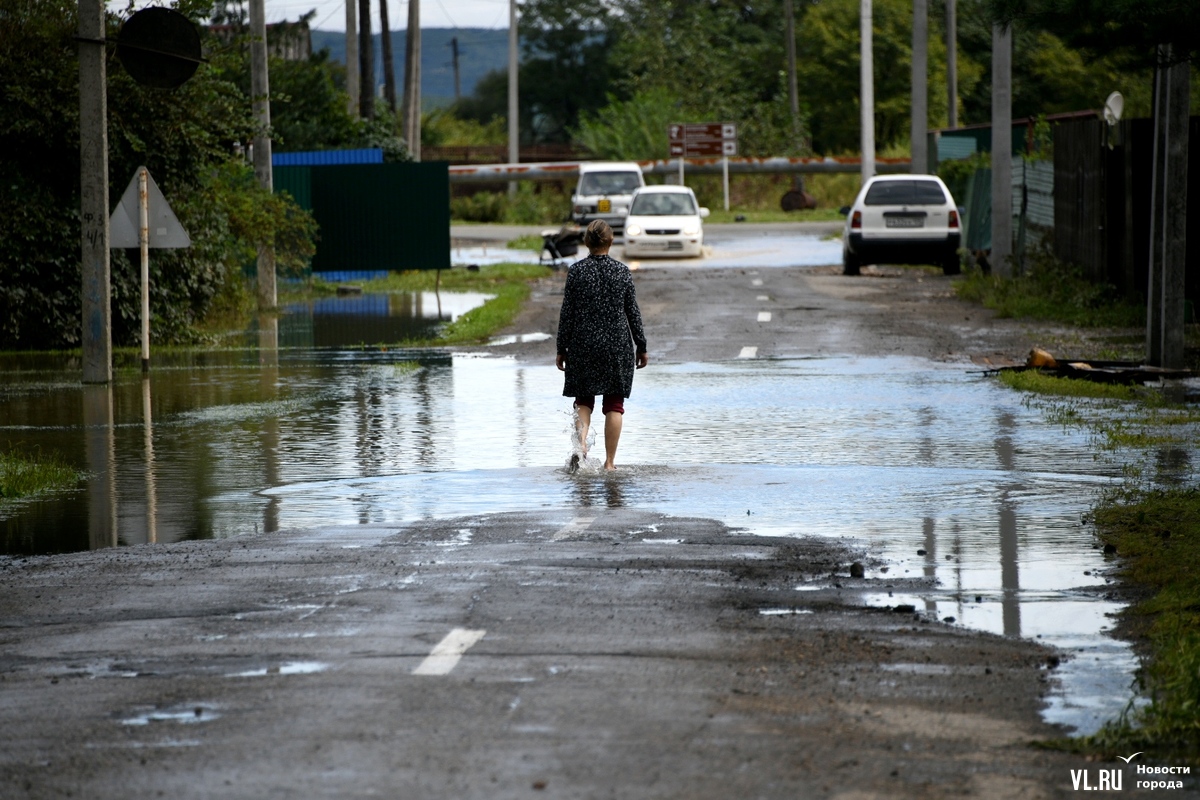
[[0, 0, 313, 348]]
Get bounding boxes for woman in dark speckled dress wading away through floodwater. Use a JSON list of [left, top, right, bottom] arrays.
[[554, 219, 649, 471]]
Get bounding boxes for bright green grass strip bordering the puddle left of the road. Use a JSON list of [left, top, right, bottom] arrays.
[[362, 264, 553, 345]]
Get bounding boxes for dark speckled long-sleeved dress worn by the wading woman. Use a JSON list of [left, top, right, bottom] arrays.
[[558, 255, 646, 397]]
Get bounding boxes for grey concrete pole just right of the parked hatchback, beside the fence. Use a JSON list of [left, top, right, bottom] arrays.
[[991, 25, 1013, 277]]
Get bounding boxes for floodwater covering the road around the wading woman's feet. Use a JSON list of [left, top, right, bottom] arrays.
[[0, 302, 1161, 733]]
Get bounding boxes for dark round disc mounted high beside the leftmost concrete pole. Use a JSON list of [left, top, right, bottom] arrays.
[[116, 7, 202, 89]]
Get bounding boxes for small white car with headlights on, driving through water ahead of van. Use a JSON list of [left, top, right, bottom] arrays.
[[625, 186, 708, 257]]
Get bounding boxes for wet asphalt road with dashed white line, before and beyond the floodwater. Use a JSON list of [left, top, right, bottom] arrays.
[[0, 251, 1180, 800]]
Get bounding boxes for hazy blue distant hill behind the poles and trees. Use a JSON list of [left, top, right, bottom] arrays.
[[312, 28, 509, 108]]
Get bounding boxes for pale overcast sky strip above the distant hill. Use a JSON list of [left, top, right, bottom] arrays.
[[108, 0, 520, 32]]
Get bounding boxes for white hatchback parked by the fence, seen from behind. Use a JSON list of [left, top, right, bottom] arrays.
[[841, 175, 962, 275]]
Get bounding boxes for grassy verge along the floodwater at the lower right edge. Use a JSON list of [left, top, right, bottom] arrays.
[[1001, 371, 1200, 765]]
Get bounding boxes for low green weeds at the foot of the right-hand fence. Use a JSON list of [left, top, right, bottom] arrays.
[[955, 249, 1146, 327]]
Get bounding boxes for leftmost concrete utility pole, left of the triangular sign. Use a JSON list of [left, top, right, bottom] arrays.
[[78, 0, 113, 384]]
